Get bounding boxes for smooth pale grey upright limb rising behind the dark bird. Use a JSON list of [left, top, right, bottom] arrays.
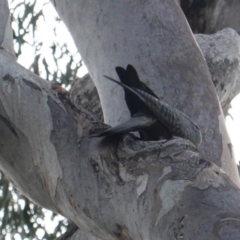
[[52, 0, 239, 184]]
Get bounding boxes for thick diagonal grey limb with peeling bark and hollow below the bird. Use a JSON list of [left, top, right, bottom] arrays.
[[0, 49, 240, 239]]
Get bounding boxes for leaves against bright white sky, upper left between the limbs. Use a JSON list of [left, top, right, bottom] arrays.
[[10, 0, 82, 86]]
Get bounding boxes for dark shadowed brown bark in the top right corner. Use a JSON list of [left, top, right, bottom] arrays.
[[179, 0, 240, 34]]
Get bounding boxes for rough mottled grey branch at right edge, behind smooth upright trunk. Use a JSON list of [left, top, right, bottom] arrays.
[[195, 28, 240, 115]]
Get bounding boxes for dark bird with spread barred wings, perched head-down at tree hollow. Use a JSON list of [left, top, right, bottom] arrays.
[[93, 65, 201, 146]]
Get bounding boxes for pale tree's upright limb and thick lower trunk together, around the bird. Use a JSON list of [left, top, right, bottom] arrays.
[[0, 0, 240, 240]]
